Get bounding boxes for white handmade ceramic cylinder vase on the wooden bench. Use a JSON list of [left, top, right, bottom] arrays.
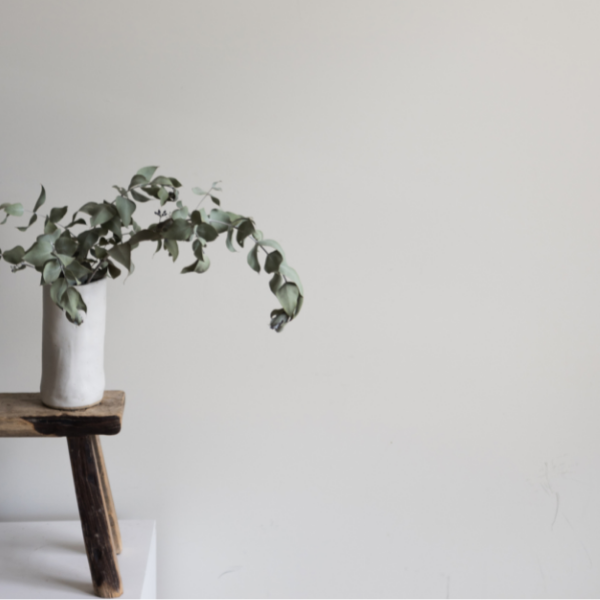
[[40, 279, 106, 410]]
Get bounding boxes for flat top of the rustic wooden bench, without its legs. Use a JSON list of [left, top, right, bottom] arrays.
[[0, 391, 125, 437]]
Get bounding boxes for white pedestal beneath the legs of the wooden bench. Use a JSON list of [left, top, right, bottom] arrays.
[[0, 521, 156, 598]]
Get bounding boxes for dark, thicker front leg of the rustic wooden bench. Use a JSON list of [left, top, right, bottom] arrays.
[[67, 435, 123, 598]]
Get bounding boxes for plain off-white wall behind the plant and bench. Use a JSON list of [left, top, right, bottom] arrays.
[[0, 0, 600, 598]]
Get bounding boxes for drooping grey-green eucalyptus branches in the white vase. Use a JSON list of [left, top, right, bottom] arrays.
[[0, 167, 304, 332]]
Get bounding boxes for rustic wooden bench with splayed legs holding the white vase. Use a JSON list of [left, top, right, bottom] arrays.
[[0, 391, 125, 598]]
